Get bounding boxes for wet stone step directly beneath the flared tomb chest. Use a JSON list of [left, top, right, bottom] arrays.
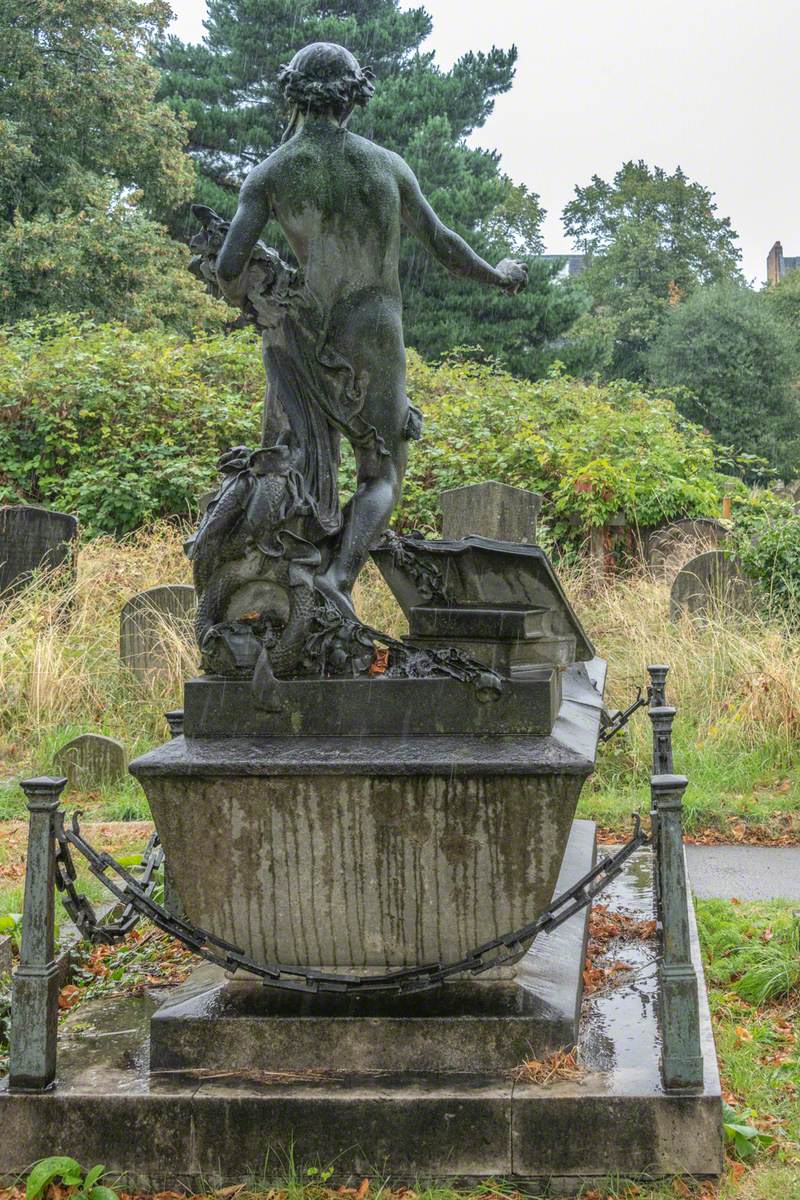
[[150, 821, 595, 1074]]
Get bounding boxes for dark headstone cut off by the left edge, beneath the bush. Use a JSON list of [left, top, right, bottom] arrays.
[[0, 504, 78, 594]]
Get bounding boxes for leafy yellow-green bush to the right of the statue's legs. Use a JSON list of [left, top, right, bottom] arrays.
[[402, 358, 720, 538]]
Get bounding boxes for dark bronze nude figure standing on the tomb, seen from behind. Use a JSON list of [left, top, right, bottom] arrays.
[[216, 42, 528, 614]]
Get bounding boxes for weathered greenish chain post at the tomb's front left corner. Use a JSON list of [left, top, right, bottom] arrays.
[[8, 775, 67, 1092]]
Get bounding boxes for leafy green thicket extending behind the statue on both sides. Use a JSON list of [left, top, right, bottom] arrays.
[[0, 317, 720, 540]]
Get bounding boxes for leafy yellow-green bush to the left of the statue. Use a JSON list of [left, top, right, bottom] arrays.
[[0, 317, 264, 534]]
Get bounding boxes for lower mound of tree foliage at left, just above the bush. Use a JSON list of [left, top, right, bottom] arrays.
[[0, 185, 229, 336]]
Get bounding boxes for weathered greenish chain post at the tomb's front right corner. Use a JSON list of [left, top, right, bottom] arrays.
[[650, 774, 703, 1091]]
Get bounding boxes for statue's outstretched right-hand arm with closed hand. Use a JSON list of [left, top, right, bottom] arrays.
[[393, 156, 528, 292]]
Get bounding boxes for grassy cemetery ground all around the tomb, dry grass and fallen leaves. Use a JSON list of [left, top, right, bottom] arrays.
[[0, 524, 800, 1200]]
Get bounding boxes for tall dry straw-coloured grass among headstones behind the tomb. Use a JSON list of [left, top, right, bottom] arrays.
[[0, 523, 800, 836]]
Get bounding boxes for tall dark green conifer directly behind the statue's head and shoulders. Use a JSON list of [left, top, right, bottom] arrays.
[[156, 0, 581, 373]]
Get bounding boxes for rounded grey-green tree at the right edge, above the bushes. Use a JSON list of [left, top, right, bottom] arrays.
[[648, 283, 800, 479]]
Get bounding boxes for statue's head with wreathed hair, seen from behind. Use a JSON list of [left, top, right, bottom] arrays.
[[278, 42, 374, 124]]
